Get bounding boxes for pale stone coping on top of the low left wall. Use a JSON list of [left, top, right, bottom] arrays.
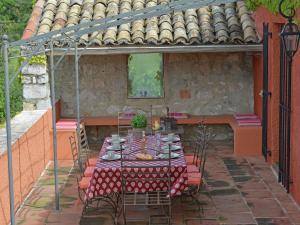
[[0, 110, 47, 156]]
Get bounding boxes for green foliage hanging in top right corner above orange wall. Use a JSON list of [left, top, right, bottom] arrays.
[[246, 0, 300, 15]]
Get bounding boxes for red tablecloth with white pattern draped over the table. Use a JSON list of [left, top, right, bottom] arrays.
[[86, 136, 187, 199]]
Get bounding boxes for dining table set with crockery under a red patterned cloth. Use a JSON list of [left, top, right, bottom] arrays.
[[85, 135, 187, 200]]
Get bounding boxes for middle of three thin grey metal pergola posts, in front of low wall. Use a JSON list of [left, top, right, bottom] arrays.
[[50, 41, 59, 210]]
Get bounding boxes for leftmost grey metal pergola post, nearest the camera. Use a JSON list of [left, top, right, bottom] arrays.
[[3, 35, 16, 225]]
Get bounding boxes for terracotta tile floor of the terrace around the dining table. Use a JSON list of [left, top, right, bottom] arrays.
[[17, 142, 300, 225]]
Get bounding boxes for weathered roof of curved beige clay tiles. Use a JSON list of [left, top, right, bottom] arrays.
[[32, 0, 259, 46]]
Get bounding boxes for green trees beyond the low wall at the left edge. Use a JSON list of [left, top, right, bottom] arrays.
[[0, 0, 33, 124]]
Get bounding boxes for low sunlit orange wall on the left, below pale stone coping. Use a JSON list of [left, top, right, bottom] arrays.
[[0, 109, 52, 225]]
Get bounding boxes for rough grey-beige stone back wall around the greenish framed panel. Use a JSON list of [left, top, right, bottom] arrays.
[[56, 53, 253, 116]]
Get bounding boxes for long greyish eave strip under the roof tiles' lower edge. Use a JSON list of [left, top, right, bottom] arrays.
[[46, 44, 263, 55]]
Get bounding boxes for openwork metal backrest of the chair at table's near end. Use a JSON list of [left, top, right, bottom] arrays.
[[121, 146, 171, 194]]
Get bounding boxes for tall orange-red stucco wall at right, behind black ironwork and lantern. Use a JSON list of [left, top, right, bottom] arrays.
[[254, 7, 300, 203]]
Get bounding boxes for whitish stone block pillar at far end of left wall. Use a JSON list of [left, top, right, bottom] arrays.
[[21, 64, 50, 110]]
